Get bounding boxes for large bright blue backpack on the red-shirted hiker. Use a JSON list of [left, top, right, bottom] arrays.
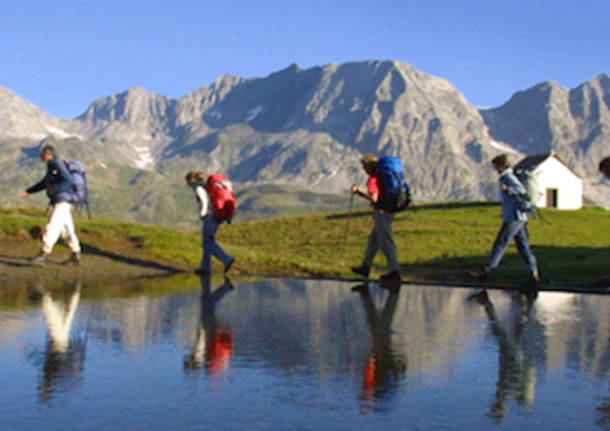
[[377, 156, 411, 212]]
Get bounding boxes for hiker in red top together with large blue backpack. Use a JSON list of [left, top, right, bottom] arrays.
[[351, 154, 409, 281]]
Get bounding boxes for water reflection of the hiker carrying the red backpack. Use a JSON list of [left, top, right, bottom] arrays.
[[184, 276, 233, 374]]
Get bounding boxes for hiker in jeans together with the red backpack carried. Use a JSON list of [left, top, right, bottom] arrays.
[[186, 172, 237, 275]]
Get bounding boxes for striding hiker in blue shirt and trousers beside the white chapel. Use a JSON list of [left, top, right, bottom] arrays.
[[471, 154, 540, 284]]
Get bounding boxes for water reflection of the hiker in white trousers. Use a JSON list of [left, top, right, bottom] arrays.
[[29, 283, 86, 401]]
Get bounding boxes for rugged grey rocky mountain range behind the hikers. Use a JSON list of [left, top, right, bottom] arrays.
[[0, 61, 610, 228]]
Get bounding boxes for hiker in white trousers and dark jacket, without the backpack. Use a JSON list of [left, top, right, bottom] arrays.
[[19, 145, 81, 265]]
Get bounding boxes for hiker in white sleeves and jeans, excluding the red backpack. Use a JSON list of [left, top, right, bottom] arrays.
[[185, 172, 235, 275]]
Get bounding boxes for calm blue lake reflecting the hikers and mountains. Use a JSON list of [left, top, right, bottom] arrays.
[[0, 277, 610, 431]]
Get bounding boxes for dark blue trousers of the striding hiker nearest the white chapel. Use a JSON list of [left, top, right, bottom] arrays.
[[485, 220, 538, 272]]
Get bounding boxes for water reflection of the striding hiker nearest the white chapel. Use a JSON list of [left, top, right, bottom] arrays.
[[469, 290, 536, 419]]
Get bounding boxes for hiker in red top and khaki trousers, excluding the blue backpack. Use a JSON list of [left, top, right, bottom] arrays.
[[351, 154, 400, 281]]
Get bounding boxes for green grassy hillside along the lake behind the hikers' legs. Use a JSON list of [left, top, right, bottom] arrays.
[[0, 203, 610, 286]]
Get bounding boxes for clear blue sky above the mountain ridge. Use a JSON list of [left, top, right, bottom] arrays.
[[0, 0, 610, 118]]
